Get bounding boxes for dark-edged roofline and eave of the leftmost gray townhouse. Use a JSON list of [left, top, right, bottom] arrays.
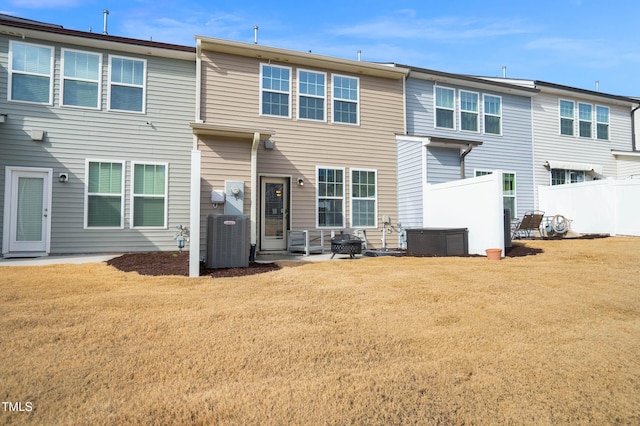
[[0, 16, 196, 61]]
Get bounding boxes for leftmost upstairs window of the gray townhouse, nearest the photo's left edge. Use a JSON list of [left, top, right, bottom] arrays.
[[8, 41, 53, 105]]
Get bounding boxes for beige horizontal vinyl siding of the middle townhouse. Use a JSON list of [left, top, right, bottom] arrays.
[[201, 52, 404, 247]]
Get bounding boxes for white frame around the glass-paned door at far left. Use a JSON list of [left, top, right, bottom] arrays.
[[2, 166, 53, 257]]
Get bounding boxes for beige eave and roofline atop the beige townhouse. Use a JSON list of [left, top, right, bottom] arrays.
[[195, 35, 409, 80]]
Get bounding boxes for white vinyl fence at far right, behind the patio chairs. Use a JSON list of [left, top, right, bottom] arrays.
[[538, 179, 640, 236]]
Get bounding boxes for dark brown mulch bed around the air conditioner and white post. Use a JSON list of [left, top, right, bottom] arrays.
[[107, 252, 280, 278]]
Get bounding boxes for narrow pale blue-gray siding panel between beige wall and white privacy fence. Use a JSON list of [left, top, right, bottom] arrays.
[[398, 140, 424, 228]]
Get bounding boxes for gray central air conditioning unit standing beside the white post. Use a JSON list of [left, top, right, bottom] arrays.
[[206, 214, 251, 268]]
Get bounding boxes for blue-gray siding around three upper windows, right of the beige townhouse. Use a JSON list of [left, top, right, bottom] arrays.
[[406, 78, 534, 220]]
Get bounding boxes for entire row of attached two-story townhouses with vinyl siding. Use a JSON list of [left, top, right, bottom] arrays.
[[0, 15, 640, 271]]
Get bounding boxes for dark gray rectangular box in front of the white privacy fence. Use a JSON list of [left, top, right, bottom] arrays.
[[407, 228, 469, 256]]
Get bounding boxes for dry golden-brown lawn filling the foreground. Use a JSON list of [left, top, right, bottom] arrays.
[[0, 237, 640, 425]]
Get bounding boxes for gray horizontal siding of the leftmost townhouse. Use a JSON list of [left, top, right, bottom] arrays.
[[0, 35, 195, 254]]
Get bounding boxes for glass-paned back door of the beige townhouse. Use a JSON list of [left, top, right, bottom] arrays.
[[260, 177, 289, 250]]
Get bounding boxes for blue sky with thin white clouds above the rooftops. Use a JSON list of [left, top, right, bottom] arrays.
[[5, 0, 640, 97]]
